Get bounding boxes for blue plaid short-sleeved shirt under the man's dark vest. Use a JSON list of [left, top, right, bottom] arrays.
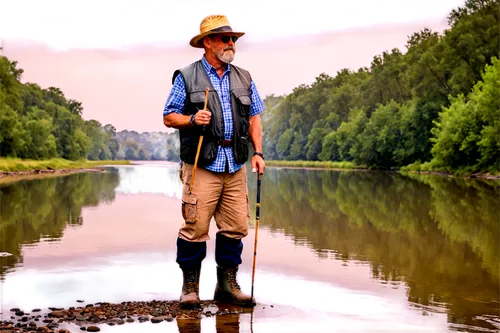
[[163, 56, 266, 173]]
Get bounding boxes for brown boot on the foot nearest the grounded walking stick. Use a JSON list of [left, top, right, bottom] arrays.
[[214, 266, 256, 307]]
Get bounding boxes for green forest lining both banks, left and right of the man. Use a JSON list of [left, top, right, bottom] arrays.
[[0, 0, 500, 172]]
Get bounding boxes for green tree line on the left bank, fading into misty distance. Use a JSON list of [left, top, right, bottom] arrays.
[[0, 48, 179, 161]]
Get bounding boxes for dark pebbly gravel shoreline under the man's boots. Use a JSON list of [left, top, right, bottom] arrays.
[[0, 300, 258, 333]]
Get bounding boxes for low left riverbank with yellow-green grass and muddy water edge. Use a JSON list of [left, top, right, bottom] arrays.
[[0, 158, 130, 177]]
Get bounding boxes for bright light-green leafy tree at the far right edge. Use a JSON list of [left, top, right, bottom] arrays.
[[432, 58, 500, 170]]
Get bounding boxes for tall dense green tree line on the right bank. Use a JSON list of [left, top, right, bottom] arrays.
[[263, 0, 500, 171]]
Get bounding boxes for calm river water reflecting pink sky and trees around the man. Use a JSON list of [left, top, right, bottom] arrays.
[[0, 166, 500, 333]]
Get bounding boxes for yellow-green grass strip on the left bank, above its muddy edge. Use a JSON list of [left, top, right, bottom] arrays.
[[0, 158, 130, 172]]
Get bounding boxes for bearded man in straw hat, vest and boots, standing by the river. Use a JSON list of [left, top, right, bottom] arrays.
[[163, 15, 265, 308]]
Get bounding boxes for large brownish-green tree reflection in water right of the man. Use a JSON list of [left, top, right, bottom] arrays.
[[249, 168, 500, 329]]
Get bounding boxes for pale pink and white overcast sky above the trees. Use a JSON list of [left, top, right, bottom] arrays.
[[0, 0, 463, 131]]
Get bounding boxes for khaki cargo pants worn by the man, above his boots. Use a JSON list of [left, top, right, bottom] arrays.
[[179, 163, 250, 242]]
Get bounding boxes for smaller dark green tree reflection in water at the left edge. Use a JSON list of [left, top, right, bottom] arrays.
[[0, 170, 120, 281]]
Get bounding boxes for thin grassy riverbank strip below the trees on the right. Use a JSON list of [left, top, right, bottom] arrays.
[[266, 160, 500, 179]]
